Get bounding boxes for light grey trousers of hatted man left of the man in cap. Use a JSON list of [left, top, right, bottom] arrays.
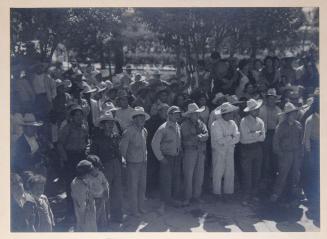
[[127, 162, 146, 214]]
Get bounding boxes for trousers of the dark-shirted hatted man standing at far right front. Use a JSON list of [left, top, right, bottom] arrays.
[[273, 150, 302, 196]]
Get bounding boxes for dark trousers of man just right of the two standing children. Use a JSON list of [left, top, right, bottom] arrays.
[[103, 159, 123, 220]]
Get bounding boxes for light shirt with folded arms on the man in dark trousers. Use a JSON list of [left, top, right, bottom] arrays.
[[240, 115, 266, 144]]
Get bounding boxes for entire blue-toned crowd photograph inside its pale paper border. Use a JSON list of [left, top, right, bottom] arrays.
[[6, 6, 321, 235]]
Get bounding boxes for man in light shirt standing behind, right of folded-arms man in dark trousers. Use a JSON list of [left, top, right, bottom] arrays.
[[259, 88, 282, 189]]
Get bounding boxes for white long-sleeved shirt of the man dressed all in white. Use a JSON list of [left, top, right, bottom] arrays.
[[211, 118, 240, 149]]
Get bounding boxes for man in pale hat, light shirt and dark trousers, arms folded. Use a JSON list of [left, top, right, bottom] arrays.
[[240, 99, 266, 204]]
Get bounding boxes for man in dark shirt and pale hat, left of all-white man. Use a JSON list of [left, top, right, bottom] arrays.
[[181, 103, 209, 204]]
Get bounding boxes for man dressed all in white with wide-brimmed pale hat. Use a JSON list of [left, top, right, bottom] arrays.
[[210, 102, 240, 197]]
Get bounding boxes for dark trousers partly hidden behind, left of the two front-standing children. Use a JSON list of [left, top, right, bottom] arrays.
[[62, 151, 85, 216]]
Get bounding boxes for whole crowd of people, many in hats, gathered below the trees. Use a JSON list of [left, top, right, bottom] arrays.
[[11, 52, 319, 232]]
